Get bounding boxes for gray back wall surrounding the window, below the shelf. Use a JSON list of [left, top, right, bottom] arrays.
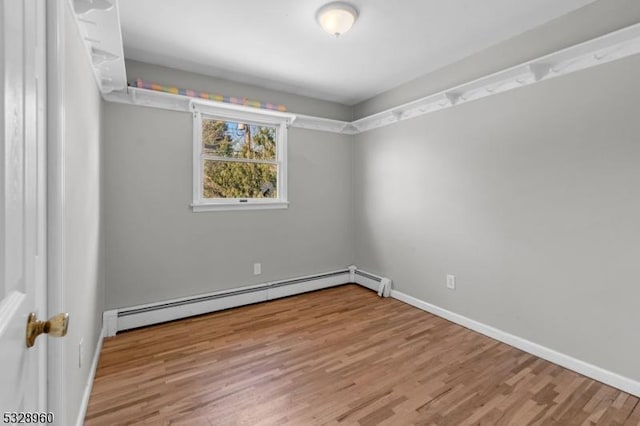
[[104, 98, 353, 309]]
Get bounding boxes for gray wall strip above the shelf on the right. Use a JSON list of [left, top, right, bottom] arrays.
[[353, 0, 640, 118]]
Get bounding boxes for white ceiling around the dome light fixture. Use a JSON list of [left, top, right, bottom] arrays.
[[119, 0, 594, 105]]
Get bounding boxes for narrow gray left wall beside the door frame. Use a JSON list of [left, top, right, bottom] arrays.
[[62, 8, 104, 424]]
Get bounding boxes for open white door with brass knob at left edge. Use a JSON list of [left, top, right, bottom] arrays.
[[0, 0, 46, 424]]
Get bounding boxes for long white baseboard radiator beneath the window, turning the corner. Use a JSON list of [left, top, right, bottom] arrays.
[[103, 266, 391, 337]]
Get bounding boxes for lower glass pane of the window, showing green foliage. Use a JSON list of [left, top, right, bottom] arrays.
[[202, 160, 278, 198]]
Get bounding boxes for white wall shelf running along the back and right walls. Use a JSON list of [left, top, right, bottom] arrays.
[[101, 22, 640, 135]]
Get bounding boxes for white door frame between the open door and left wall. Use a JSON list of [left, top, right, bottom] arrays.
[[43, 0, 66, 425]]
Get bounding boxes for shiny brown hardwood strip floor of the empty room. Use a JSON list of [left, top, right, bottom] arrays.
[[85, 285, 640, 426]]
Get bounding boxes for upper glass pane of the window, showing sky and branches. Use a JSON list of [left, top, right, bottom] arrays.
[[202, 118, 277, 160]]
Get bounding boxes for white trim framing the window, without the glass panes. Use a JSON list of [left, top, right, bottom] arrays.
[[190, 100, 296, 212]]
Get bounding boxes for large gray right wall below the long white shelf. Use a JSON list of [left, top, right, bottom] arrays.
[[353, 56, 640, 380]]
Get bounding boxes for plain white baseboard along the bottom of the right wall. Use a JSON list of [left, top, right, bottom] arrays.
[[391, 290, 640, 397]]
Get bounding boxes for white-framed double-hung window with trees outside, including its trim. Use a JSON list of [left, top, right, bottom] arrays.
[[192, 101, 294, 212]]
